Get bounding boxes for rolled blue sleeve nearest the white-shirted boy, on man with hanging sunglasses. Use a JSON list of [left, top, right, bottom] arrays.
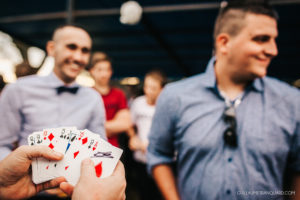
[[147, 86, 179, 174]]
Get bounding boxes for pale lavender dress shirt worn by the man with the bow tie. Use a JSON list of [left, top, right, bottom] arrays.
[[0, 73, 106, 160]]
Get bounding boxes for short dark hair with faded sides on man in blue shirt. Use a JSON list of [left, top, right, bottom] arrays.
[[213, 0, 278, 43]]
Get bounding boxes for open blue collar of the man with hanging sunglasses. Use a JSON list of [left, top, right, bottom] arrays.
[[204, 56, 263, 92]]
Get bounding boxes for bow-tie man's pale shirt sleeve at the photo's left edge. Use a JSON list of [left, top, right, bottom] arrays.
[[0, 84, 22, 160]]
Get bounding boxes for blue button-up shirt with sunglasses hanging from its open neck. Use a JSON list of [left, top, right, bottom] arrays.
[[147, 58, 300, 200]]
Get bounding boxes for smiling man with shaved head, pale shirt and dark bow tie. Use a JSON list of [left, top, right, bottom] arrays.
[[0, 25, 106, 160]]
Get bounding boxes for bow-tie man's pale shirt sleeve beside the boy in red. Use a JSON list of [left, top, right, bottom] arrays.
[[87, 92, 107, 140]]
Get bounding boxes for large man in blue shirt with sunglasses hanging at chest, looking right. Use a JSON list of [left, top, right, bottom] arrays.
[[147, 0, 300, 200]]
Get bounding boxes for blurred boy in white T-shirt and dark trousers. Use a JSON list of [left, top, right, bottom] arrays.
[[128, 70, 167, 200]]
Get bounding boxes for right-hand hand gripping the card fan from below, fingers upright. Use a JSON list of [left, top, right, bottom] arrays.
[[60, 159, 126, 200]]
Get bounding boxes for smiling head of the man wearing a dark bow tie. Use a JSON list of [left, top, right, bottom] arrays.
[[47, 25, 92, 84]]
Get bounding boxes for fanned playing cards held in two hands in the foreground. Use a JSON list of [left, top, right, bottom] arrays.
[[28, 127, 123, 185]]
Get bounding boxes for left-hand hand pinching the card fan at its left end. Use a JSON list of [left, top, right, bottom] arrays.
[[0, 146, 65, 199]]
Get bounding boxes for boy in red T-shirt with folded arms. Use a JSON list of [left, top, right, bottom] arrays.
[[88, 52, 132, 147]]
